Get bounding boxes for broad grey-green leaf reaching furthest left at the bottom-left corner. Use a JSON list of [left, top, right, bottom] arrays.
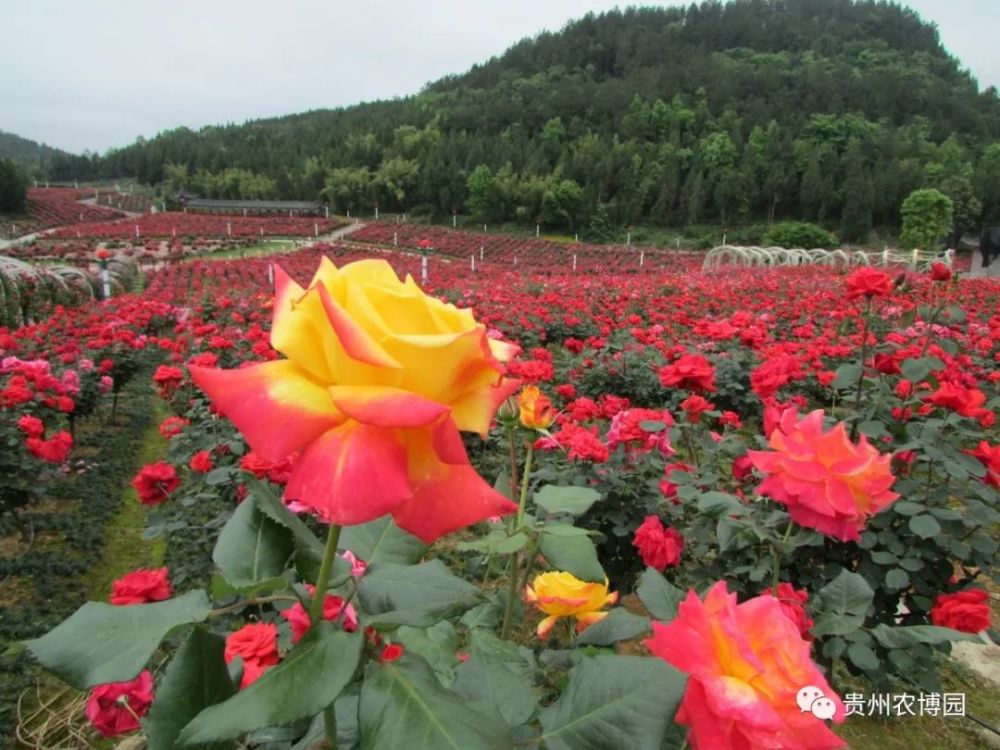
[[26, 589, 212, 690]]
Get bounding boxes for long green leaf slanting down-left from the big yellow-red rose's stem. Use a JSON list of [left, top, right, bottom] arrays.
[[179, 622, 364, 745]]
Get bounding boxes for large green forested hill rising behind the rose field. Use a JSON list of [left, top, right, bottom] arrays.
[[48, 0, 1000, 239]]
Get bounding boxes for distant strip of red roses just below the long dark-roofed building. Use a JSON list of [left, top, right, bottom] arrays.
[[47, 211, 343, 240]]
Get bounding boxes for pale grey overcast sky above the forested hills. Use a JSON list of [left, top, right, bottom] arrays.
[[0, 0, 1000, 152]]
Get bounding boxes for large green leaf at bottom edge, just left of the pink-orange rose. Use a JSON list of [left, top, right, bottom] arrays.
[[539, 656, 687, 750]]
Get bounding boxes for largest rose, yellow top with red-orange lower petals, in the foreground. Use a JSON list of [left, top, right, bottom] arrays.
[[190, 258, 518, 542]]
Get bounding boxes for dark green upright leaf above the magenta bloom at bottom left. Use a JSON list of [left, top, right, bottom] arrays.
[[142, 625, 236, 750]]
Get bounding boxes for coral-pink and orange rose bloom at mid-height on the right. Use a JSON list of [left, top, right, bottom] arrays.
[[747, 408, 899, 542]]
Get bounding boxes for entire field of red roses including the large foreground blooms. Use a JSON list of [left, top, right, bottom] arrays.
[[0, 241, 1000, 750]]
